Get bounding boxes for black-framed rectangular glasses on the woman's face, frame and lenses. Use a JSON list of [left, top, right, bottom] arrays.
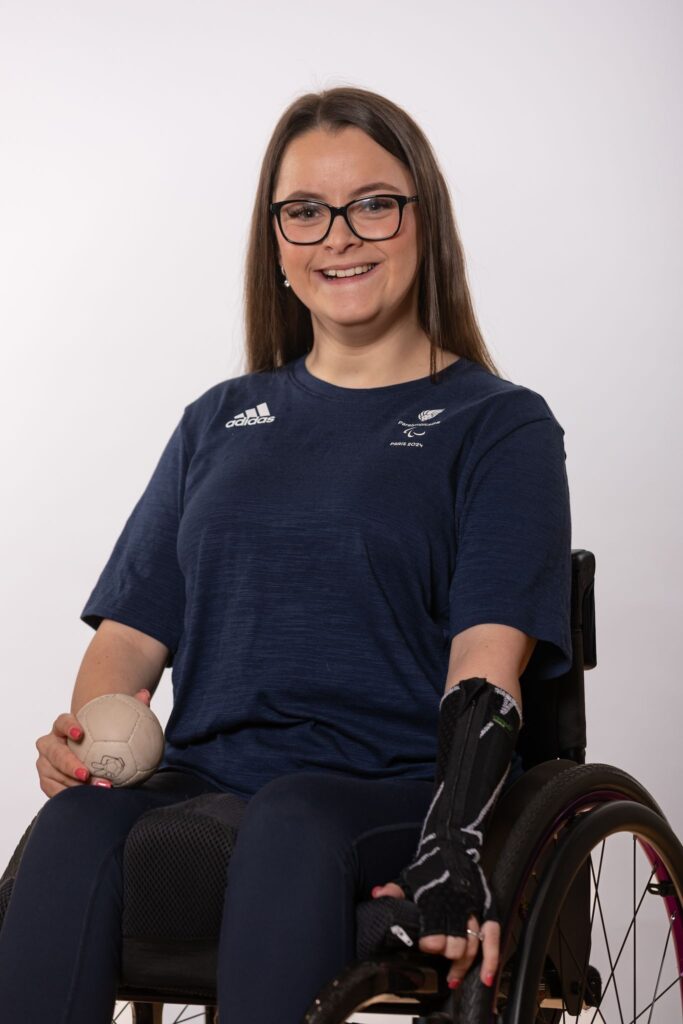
[[270, 194, 418, 246]]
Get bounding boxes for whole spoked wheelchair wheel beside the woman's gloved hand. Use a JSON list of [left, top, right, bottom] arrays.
[[457, 762, 683, 1024]]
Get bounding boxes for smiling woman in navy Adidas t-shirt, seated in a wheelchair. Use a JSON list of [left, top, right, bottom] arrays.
[[0, 88, 571, 1024]]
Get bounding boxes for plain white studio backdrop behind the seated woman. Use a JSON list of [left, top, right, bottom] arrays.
[[0, 0, 683, 1007]]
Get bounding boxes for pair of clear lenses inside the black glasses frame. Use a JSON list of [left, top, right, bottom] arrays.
[[281, 196, 400, 242]]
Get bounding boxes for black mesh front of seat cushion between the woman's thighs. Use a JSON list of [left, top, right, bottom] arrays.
[[122, 793, 246, 941]]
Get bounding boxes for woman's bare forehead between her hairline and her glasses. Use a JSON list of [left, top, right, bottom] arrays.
[[273, 126, 413, 201]]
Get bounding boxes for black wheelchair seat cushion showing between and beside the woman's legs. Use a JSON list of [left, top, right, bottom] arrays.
[[0, 794, 432, 1002]]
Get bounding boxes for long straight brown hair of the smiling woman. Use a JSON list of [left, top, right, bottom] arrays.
[[245, 86, 501, 379]]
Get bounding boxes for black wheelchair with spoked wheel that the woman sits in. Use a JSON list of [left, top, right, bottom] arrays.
[[0, 549, 683, 1024]]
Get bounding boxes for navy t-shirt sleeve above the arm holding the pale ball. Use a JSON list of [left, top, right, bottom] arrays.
[[80, 413, 187, 668]]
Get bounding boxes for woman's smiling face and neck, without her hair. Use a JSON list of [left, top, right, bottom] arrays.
[[273, 126, 430, 374]]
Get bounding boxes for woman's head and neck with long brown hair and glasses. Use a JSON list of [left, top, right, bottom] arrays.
[[246, 88, 498, 387]]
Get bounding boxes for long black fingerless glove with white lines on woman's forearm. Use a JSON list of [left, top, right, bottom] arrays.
[[394, 678, 521, 937]]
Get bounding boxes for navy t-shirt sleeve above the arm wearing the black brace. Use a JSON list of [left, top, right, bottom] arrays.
[[450, 395, 572, 679]]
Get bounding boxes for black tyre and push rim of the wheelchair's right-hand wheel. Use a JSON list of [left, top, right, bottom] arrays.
[[457, 762, 683, 1024]]
